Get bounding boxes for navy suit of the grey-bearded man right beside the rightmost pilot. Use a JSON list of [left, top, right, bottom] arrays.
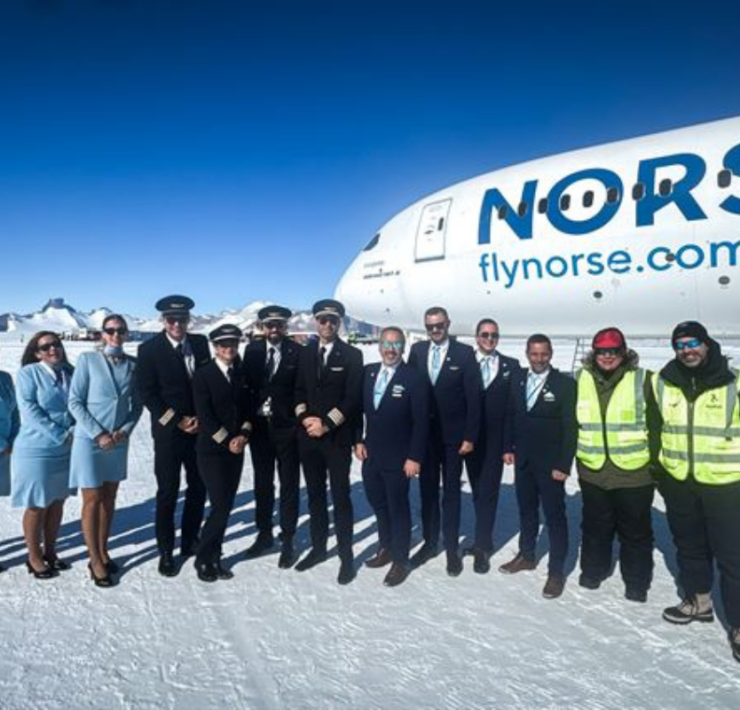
[[362, 362, 429, 565]]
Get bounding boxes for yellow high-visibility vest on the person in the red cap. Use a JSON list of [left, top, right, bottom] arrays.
[[576, 368, 650, 471]]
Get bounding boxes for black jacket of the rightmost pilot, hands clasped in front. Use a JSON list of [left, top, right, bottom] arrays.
[[295, 339, 363, 446]]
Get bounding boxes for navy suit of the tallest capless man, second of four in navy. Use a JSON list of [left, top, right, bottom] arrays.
[[409, 340, 482, 554]]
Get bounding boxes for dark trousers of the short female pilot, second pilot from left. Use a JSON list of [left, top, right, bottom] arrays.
[[195, 451, 244, 563]]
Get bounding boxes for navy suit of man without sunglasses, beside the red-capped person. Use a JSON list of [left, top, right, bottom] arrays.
[[505, 369, 578, 575]]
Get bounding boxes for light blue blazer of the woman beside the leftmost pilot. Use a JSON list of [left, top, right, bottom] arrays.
[[69, 352, 142, 439]]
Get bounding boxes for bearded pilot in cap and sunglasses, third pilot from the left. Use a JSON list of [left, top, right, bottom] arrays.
[[243, 305, 303, 569]]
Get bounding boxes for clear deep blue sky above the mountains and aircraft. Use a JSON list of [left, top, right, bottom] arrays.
[[0, 0, 740, 315]]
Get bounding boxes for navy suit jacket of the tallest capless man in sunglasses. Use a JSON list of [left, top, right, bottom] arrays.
[[409, 340, 483, 446]]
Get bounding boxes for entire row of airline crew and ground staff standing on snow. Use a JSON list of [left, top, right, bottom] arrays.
[[0, 296, 740, 661]]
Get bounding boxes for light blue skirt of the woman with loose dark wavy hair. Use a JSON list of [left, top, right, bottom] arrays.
[[10, 447, 76, 508]]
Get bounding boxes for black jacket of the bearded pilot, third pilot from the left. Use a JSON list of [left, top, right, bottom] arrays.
[[242, 338, 303, 427]]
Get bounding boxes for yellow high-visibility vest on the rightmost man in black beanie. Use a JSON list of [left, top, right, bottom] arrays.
[[653, 369, 740, 485]]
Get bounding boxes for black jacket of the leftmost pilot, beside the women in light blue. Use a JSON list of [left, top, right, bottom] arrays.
[[137, 331, 211, 440]]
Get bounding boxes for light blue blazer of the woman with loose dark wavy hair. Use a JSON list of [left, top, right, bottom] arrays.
[[13, 363, 74, 456]]
